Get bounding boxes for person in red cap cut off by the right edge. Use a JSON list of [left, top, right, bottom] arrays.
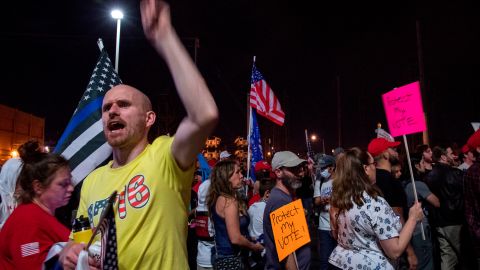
[[463, 129, 480, 269]]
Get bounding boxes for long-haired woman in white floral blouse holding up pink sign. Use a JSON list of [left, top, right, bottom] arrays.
[[329, 148, 423, 270]]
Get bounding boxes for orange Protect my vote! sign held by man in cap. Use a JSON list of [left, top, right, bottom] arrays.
[[270, 200, 310, 261]]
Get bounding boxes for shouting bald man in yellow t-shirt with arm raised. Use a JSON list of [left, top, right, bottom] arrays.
[[59, 0, 218, 269]]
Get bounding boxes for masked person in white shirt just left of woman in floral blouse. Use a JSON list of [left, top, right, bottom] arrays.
[[313, 155, 337, 270]]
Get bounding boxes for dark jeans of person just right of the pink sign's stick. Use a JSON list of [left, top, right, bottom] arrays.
[[410, 226, 433, 270]]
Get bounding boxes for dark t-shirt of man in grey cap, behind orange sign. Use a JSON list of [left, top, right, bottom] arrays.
[[263, 187, 311, 270]]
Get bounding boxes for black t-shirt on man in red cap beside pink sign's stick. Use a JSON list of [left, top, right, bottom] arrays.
[[376, 168, 407, 209]]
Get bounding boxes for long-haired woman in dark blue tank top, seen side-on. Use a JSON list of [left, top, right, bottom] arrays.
[[207, 160, 263, 270]]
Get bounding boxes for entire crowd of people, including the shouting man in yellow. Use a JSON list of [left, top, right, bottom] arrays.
[[0, 0, 480, 270]]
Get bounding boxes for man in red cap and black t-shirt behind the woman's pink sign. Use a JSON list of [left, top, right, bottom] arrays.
[[368, 138, 418, 269]]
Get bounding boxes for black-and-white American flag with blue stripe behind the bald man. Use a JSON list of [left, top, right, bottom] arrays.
[[54, 49, 122, 185]]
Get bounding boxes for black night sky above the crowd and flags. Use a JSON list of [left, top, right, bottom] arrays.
[[0, 0, 480, 154]]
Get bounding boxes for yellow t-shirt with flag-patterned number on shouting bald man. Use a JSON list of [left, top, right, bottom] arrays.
[[77, 136, 193, 270]]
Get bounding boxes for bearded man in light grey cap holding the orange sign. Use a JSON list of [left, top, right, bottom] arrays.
[[263, 151, 311, 270]]
